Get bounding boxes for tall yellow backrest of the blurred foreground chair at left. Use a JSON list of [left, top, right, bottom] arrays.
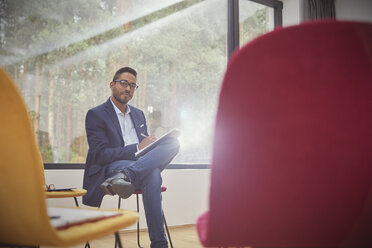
[[0, 68, 57, 245]]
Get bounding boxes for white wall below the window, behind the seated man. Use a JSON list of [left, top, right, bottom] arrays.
[[45, 169, 210, 229]]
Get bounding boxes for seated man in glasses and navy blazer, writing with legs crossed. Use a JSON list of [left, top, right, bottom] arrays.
[[83, 67, 179, 247]]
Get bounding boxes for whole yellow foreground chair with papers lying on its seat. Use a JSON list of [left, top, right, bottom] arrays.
[[0, 69, 138, 247]]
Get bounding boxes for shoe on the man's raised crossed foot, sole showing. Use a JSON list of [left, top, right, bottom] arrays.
[[101, 172, 134, 199]]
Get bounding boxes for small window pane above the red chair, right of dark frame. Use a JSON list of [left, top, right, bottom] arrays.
[[239, 0, 275, 46]]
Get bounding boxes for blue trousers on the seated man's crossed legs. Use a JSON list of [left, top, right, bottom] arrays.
[[108, 138, 179, 248]]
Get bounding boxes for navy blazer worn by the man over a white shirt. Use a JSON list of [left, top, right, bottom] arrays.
[[83, 98, 148, 207]]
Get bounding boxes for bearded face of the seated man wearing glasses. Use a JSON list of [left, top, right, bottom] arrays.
[[110, 72, 137, 104]]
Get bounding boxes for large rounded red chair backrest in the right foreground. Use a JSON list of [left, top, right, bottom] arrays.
[[206, 21, 372, 247]]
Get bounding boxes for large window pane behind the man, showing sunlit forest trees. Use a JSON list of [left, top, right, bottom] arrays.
[[0, 0, 227, 163]]
